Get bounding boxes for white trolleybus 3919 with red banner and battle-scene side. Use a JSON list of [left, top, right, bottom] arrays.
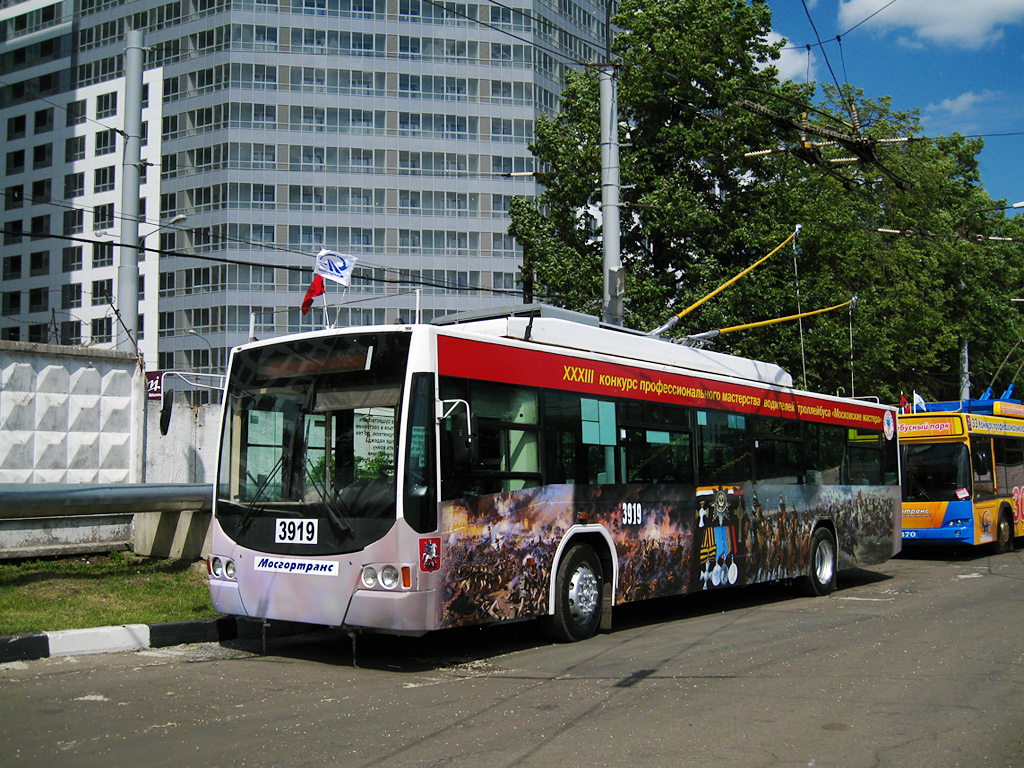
[[210, 305, 901, 640]]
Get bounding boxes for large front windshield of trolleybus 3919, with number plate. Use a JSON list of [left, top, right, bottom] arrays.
[[215, 333, 410, 555]]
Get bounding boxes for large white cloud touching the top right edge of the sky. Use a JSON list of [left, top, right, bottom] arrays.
[[839, 0, 1024, 49]]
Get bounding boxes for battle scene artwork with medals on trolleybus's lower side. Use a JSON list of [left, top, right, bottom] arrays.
[[440, 483, 898, 627]]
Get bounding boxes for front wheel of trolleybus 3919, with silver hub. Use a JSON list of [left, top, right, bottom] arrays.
[[546, 544, 602, 643]]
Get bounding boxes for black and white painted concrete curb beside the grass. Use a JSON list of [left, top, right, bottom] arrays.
[[0, 616, 310, 664]]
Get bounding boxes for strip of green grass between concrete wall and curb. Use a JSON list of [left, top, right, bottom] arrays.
[[0, 552, 218, 637]]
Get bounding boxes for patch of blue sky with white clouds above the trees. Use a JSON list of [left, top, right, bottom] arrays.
[[768, 0, 1024, 208]]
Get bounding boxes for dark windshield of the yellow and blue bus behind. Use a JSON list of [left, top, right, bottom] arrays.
[[900, 442, 971, 502]]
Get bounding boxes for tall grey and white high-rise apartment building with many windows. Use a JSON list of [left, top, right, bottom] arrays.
[[0, 0, 605, 372]]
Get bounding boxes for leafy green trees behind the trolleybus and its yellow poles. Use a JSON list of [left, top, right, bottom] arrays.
[[510, 0, 1024, 401]]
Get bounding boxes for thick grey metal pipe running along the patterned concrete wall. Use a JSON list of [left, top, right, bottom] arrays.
[[0, 482, 213, 520]]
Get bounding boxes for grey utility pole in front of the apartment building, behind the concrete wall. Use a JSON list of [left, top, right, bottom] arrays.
[[117, 30, 143, 352]]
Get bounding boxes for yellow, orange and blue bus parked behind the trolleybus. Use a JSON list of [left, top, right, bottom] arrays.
[[898, 399, 1024, 553]]
